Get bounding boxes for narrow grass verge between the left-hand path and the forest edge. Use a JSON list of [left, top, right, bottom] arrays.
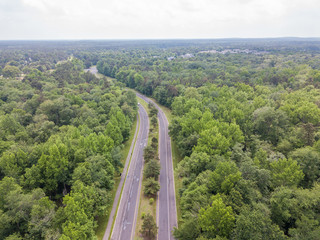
[[96, 116, 137, 240]]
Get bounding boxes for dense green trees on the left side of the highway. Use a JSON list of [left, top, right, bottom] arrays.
[[0, 58, 137, 240]]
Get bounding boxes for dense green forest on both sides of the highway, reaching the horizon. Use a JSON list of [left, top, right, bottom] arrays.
[[0, 39, 320, 240]]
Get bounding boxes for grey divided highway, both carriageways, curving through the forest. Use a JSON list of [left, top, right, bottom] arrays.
[[86, 66, 178, 240]]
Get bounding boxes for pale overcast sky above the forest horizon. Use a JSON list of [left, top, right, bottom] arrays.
[[0, 0, 320, 40]]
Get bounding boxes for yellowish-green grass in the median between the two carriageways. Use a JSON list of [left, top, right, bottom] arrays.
[[134, 98, 159, 240]]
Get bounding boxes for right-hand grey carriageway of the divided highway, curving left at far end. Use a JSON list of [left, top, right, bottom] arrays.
[[136, 93, 178, 240]]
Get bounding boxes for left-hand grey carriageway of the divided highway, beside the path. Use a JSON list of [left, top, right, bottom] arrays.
[[111, 105, 149, 240]]
